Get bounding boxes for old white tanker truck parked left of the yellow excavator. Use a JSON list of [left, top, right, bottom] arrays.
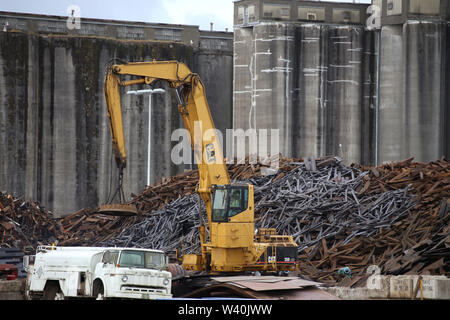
[[25, 246, 172, 300]]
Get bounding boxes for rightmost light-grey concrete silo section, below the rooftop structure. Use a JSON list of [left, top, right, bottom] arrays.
[[378, 21, 448, 163]]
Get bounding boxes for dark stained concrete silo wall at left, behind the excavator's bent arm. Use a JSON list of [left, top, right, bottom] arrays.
[[0, 32, 232, 215]]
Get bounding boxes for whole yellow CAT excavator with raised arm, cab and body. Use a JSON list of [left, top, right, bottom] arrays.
[[104, 61, 298, 274]]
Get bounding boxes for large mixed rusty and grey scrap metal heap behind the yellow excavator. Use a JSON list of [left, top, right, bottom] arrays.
[[0, 157, 450, 286]]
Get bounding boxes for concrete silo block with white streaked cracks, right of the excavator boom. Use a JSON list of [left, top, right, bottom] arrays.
[[234, 23, 374, 162]]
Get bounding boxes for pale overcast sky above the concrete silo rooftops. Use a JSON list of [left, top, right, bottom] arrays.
[[0, 0, 371, 31]]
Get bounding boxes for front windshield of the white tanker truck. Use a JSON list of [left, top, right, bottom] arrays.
[[119, 250, 165, 269]]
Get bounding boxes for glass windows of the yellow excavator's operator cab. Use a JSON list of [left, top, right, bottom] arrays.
[[212, 186, 248, 222]]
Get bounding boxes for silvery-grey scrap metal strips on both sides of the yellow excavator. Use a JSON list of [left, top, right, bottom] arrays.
[[100, 158, 414, 256]]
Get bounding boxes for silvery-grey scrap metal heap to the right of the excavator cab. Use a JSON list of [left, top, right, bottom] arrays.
[[252, 159, 414, 257]]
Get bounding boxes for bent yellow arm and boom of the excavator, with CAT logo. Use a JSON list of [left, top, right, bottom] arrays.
[[104, 61, 230, 210]]
